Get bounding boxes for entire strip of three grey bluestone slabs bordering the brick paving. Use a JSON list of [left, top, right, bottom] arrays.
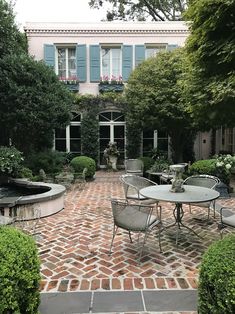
[[39, 290, 197, 314]]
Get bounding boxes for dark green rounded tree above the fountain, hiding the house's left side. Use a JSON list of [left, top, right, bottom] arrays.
[[0, 54, 72, 154]]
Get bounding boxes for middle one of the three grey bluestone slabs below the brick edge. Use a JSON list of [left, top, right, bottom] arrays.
[[92, 291, 144, 313]]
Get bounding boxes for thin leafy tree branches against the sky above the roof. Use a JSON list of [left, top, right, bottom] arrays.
[[89, 0, 187, 21]]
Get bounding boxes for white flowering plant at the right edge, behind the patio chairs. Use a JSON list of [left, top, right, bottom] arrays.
[[215, 154, 235, 184]]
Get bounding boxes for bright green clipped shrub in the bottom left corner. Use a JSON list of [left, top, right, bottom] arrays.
[[0, 226, 40, 314]]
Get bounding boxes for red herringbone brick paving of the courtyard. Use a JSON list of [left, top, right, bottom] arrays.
[[37, 171, 235, 292]]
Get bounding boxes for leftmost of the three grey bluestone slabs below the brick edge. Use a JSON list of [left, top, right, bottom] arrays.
[[39, 292, 92, 314]]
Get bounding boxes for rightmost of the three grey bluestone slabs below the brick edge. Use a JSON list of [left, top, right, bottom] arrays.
[[143, 290, 197, 311]]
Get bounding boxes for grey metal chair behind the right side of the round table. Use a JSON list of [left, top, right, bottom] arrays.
[[184, 174, 220, 221]]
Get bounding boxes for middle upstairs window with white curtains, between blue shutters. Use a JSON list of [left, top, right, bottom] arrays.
[[101, 47, 121, 80]]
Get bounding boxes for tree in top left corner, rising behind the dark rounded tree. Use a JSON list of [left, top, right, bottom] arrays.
[[0, 0, 27, 58]]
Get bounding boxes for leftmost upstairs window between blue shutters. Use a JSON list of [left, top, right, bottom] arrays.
[[57, 47, 76, 79]]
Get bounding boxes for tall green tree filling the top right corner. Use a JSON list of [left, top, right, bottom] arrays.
[[185, 0, 235, 129]]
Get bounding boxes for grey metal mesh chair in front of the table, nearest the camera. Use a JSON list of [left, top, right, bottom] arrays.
[[109, 199, 162, 262]]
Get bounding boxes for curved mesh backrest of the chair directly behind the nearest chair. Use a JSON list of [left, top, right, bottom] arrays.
[[120, 174, 157, 198]]
